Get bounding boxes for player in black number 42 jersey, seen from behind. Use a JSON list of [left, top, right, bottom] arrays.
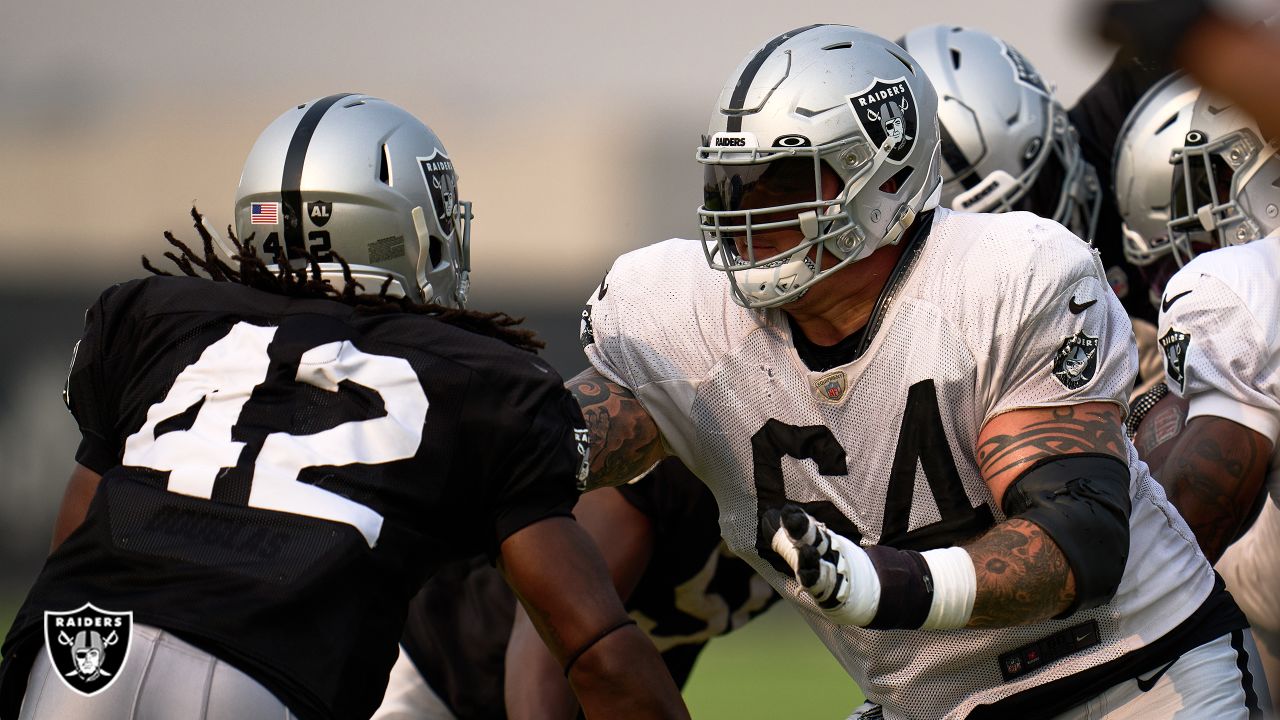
[[0, 95, 687, 720]]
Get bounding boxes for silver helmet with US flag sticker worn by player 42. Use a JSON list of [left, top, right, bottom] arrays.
[[236, 94, 471, 307]]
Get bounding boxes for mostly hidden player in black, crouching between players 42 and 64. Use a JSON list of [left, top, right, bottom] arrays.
[[374, 459, 778, 720]]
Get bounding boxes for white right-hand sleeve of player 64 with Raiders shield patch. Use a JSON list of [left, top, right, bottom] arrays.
[[957, 213, 1138, 424]]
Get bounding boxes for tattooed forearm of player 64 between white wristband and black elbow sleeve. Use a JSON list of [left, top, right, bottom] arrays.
[[965, 518, 1075, 628]]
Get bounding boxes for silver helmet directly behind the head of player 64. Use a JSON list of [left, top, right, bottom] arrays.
[[901, 24, 1102, 242]]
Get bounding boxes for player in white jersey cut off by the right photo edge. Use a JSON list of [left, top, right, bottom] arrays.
[[1137, 95, 1280, 710]]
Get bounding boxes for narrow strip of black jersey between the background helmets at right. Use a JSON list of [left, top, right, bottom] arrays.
[[1068, 54, 1172, 319]]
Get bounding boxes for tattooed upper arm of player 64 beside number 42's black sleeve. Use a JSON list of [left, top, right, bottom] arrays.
[[564, 368, 667, 489]]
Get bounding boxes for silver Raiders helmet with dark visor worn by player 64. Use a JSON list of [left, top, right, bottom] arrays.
[[698, 24, 941, 307]]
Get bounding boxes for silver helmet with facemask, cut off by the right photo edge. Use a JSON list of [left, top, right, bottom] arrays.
[[1169, 92, 1280, 264]]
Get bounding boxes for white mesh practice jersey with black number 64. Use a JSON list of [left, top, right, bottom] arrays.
[[582, 210, 1213, 717]]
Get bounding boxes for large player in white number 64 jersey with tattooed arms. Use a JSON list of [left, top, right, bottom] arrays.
[[570, 26, 1252, 717]]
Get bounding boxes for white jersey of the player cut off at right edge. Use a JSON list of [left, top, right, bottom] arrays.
[[1158, 236, 1280, 502]]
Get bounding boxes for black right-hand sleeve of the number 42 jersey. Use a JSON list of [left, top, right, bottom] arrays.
[[492, 378, 588, 547]]
